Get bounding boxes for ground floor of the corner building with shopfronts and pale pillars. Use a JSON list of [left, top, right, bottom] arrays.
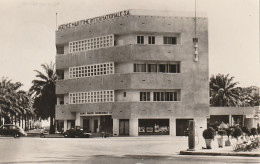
[[57, 114, 207, 136]]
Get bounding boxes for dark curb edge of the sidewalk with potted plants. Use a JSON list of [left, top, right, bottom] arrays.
[[180, 151, 260, 157]]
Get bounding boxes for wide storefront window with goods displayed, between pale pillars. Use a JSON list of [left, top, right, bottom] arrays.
[[138, 119, 170, 135]]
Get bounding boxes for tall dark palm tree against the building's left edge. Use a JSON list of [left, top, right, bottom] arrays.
[[29, 62, 57, 133]]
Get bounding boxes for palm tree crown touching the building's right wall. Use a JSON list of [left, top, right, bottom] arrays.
[[210, 74, 242, 106]]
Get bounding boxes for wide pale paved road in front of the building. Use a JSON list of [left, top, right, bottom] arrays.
[[0, 136, 260, 164]]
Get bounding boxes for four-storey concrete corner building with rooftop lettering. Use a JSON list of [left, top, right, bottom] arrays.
[[56, 10, 209, 136]]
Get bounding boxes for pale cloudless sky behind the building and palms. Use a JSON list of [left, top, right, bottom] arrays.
[[0, 0, 260, 90]]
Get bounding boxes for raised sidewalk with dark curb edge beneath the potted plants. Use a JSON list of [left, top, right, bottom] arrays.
[[180, 140, 260, 157]]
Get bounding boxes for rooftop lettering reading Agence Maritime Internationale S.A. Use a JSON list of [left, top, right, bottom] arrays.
[[59, 10, 130, 30]]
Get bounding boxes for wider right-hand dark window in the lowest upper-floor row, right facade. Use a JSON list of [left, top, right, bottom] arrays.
[[153, 92, 178, 101]]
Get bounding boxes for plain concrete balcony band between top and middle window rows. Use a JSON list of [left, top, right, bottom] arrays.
[[56, 45, 186, 69]]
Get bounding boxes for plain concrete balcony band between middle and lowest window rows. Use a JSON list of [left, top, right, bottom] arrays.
[[56, 73, 184, 94]]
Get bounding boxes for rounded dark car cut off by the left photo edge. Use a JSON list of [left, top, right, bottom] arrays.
[[0, 124, 27, 138]]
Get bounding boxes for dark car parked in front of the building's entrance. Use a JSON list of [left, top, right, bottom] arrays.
[[63, 126, 92, 138]]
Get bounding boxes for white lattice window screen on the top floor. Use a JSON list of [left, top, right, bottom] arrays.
[[69, 35, 115, 53]]
